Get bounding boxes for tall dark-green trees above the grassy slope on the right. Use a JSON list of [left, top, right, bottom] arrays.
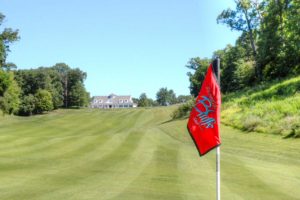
[[186, 0, 300, 96]]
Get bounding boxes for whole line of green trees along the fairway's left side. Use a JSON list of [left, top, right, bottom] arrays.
[[0, 13, 89, 116]]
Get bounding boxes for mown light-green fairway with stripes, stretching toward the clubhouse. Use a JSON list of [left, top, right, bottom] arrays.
[[0, 107, 300, 200]]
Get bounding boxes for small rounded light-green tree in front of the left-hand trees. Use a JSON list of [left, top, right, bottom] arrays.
[[34, 89, 54, 114]]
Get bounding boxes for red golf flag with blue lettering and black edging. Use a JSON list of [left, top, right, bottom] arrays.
[[188, 64, 221, 156]]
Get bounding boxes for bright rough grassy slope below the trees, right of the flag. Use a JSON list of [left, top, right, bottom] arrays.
[[222, 76, 300, 137]]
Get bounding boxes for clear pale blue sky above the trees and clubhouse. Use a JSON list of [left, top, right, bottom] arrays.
[[0, 0, 239, 99]]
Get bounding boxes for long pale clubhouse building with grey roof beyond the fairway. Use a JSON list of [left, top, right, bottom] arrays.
[[90, 94, 137, 109]]
